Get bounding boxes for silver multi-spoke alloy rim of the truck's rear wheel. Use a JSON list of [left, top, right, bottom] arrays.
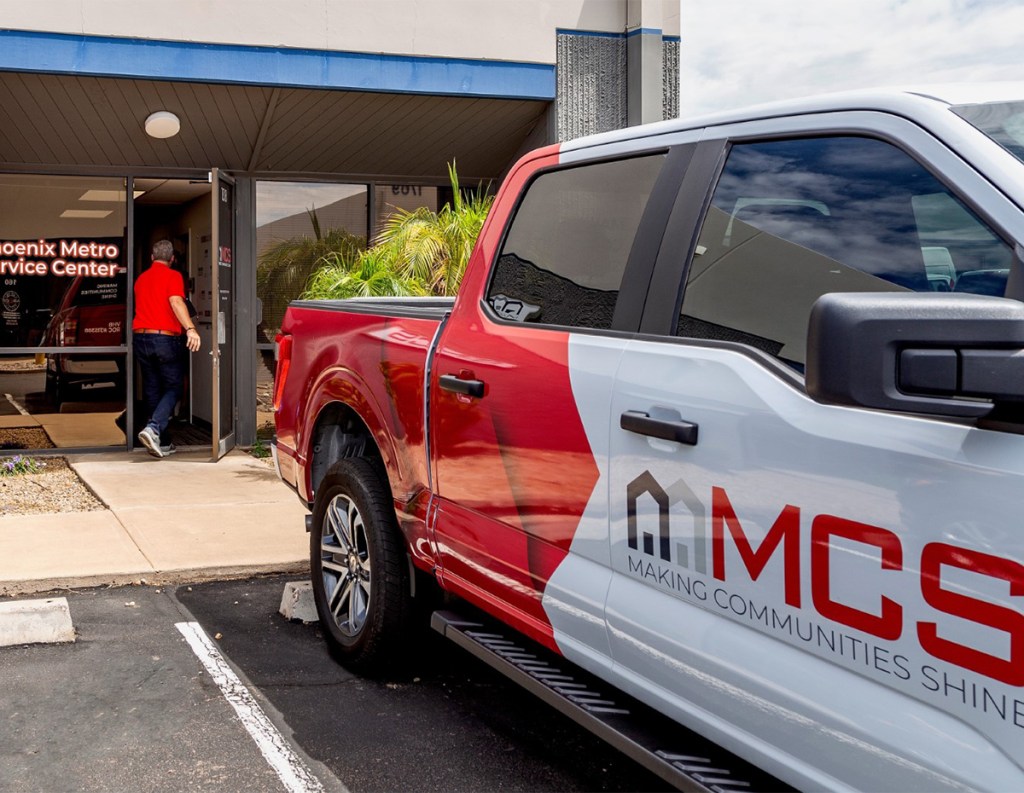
[[321, 495, 373, 637]]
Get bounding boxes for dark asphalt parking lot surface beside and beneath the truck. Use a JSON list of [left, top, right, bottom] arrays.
[[0, 578, 666, 793]]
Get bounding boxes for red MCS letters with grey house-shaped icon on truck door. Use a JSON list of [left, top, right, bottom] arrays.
[[626, 471, 1024, 686]]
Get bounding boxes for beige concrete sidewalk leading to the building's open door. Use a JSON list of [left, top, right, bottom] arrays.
[[0, 451, 309, 596]]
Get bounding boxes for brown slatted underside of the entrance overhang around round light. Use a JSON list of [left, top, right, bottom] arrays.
[[0, 72, 549, 183]]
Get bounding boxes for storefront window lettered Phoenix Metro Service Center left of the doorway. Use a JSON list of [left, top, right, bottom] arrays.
[[0, 174, 128, 453]]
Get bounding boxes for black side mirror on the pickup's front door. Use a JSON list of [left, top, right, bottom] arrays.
[[806, 292, 1024, 418]]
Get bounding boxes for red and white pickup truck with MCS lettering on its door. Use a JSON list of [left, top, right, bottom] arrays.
[[274, 84, 1024, 791]]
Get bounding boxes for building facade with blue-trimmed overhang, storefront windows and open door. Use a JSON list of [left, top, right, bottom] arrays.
[[0, 0, 680, 456]]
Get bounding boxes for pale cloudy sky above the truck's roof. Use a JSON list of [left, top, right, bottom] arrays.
[[680, 0, 1024, 118]]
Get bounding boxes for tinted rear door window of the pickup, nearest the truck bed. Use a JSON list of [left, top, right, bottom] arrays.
[[487, 154, 665, 328]]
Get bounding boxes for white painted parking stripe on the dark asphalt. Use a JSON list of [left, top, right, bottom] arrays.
[[174, 622, 324, 793]]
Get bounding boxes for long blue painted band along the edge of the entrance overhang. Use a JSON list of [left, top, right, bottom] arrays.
[[0, 30, 555, 100]]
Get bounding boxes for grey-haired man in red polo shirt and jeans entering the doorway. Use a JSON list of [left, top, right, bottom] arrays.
[[131, 240, 200, 457]]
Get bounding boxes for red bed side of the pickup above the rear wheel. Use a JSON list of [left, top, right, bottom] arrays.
[[275, 297, 455, 512]]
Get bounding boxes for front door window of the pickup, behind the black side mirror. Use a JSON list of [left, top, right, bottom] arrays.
[[677, 137, 1013, 368]]
